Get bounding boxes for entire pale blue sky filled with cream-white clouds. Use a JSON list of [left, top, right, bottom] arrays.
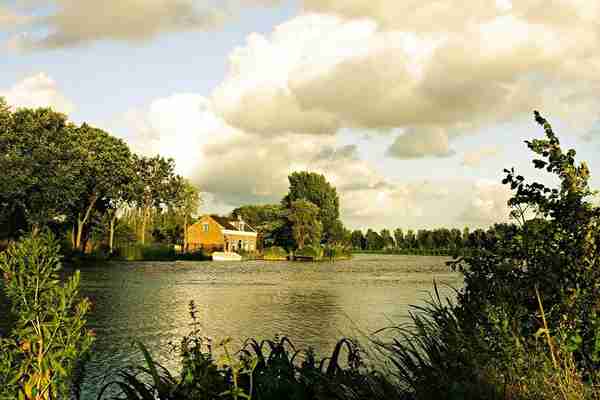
[[0, 0, 600, 229]]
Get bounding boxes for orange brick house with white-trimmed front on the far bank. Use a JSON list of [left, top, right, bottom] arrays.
[[188, 215, 257, 252]]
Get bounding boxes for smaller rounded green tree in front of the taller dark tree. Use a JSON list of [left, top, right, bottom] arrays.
[[288, 199, 323, 249]]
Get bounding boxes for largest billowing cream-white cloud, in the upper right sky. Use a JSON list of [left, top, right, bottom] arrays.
[[213, 10, 600, 157]]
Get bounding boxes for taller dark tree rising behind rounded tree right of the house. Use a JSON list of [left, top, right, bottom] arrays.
[[282, 171, 340, 241]]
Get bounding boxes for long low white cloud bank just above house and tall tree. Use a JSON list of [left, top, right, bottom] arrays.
[[121, 94, 508, 229]]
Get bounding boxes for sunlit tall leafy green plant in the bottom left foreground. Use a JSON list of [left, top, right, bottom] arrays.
[[0, 234, 93, 399]]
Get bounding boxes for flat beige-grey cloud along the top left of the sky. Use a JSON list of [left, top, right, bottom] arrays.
[[5, 0, 270, 50]]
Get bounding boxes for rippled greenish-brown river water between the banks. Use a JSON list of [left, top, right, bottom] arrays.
[[1, 255, 462, 399]]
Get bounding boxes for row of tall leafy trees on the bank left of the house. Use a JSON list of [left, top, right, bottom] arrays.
[[0, 98, 201, 252]]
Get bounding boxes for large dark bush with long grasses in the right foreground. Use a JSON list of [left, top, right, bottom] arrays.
[[380, 112, 600, 400]]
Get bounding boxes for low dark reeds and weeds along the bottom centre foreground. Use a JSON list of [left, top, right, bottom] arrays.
[[98, 303, 399, 400]]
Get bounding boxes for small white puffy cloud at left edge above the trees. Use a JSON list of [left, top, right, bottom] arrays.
[[0, 72, 75, 114]]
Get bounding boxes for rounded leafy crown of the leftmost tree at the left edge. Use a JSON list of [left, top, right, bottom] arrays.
[[0, 108, 84, 236]]
